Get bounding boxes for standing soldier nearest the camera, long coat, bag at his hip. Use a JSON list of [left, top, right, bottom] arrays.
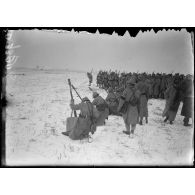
[[118, 79, 139, 138]]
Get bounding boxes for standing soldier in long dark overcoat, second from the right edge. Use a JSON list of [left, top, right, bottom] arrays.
[[162, 79, 181, 124]]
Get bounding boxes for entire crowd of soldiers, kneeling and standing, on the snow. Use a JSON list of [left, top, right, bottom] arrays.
[[64, 71, 194, 139]]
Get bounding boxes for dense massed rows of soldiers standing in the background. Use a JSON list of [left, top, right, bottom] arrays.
[[96, 70, 185, 99]]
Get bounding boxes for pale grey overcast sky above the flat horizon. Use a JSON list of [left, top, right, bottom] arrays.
[[12, 29, 193, 74]]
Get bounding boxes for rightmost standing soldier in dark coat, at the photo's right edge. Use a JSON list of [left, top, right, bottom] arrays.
[[181, 74, 194, 126]]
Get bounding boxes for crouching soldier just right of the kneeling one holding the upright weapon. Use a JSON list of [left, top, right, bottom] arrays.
[[92, 92, 109, 126]]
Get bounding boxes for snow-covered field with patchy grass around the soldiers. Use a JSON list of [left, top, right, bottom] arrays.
[[6, 70, 194, 165]]
